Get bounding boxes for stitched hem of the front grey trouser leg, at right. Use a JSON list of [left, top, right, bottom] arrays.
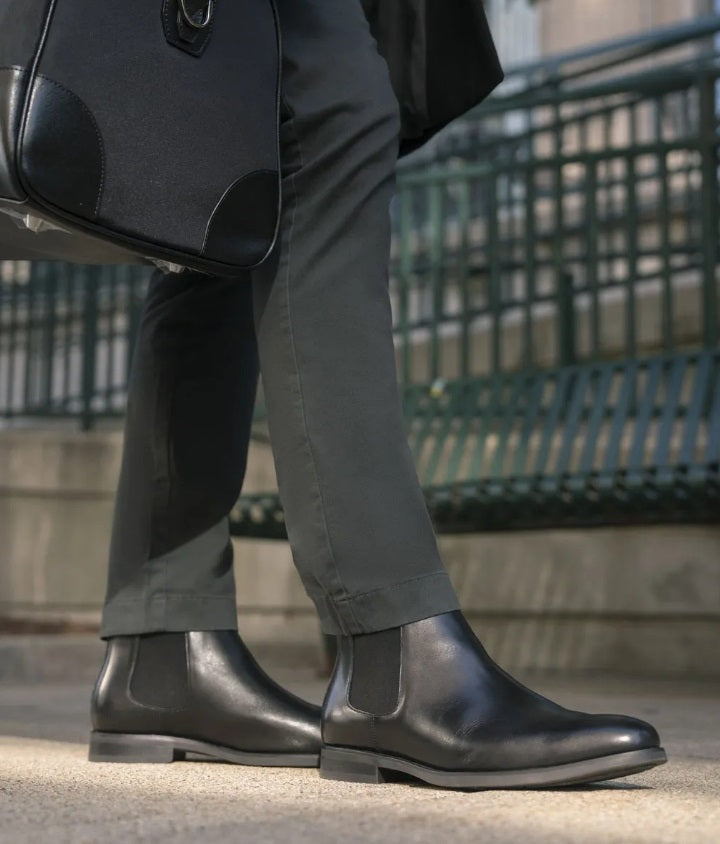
[[311, 572, 460, 636]]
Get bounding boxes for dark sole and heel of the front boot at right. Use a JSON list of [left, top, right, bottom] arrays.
[[320, 745, 667, 789]]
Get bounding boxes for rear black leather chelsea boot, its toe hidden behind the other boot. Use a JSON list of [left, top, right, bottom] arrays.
[[89, 630, 320, 768]]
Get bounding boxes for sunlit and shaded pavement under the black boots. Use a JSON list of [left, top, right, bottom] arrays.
[[0, 665, 720, 844]]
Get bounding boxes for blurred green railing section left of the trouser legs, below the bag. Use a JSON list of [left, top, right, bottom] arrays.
[[0, 262, 149, 429]]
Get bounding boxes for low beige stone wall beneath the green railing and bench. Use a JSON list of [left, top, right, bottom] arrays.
[[0, 430, 720, 677]]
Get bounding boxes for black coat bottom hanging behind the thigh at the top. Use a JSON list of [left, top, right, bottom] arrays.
[[362, 0, 503, 154]]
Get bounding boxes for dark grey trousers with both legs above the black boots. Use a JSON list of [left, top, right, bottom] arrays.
[[101, 0, 458, 637]]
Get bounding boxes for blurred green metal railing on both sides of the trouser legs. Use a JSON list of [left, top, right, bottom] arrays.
[[0, 17, 720, 427]]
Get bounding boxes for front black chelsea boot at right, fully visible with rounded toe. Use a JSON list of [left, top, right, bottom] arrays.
[[320, 612, 666, 789]]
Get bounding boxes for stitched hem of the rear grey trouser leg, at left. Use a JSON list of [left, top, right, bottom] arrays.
[[100, 595, 237, 639]]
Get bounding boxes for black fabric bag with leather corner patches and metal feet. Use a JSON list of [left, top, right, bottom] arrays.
[[0, 0, 280, 275]]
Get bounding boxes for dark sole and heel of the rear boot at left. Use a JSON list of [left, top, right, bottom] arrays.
[[88, 730, 320, 768]]
